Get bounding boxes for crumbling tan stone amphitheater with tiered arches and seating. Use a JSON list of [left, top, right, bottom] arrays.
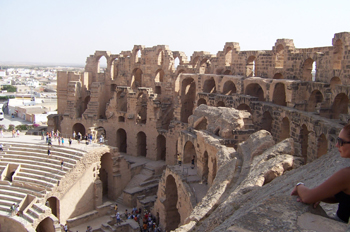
[[0, 32, 350, 232]]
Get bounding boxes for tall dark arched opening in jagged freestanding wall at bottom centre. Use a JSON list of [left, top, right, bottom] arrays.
[[164, 175, 181, 231]]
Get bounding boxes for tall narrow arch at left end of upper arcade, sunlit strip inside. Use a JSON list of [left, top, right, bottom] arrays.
[[181, 78, 196, 123]]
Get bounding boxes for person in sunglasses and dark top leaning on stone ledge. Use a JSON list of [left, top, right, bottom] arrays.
[[291, 124, 350, 223]]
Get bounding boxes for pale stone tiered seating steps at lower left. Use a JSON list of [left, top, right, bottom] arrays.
[[0, 142, 86, 231]]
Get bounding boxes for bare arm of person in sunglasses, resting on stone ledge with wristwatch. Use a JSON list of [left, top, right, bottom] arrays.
[[291, 168, 350, 204]]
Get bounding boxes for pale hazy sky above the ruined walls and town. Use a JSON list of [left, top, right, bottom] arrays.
[[0, 0, 350, 65]]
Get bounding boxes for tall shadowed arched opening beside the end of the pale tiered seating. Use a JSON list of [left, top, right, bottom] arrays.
[[99, 153, 113, 198]]
